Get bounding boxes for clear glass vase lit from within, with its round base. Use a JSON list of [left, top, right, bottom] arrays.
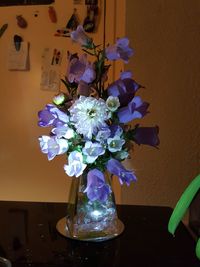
[[57, 175, 124, 241]]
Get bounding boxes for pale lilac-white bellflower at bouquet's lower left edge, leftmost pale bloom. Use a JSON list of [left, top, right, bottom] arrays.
[[39, 135, 68, 160]]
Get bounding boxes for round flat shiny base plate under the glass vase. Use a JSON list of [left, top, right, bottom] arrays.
[[56, 217, 124, 242]]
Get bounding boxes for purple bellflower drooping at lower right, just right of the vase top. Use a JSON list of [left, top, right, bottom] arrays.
[[106, 159, 137, 185]]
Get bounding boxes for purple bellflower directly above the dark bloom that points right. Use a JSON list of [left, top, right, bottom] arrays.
[[117, 96, 149, 123]]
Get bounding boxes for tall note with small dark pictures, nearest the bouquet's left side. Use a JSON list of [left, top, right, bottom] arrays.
[[40, 48, 63, 91]]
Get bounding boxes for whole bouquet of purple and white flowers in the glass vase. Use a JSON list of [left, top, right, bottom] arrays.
[[38, 26, 159, 202]]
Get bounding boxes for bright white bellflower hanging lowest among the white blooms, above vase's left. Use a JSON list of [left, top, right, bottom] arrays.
[[64, 151, 87, 177]]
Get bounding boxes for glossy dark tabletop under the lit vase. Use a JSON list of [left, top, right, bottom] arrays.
[[0, 201, 200, 267]]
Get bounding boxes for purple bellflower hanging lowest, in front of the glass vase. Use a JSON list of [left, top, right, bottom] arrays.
[[84, 169, 112, 202]]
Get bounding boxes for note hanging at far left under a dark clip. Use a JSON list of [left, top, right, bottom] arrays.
[[8, 42, 29, 70]]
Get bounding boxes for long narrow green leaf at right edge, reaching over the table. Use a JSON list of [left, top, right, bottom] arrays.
[[168, 174, 200, 236]]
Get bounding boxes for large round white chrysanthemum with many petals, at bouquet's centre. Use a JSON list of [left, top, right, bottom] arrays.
[[69, 96, 108, 139]]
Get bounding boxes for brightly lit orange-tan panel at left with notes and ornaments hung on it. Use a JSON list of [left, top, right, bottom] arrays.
[[0, 0, 107, 202]]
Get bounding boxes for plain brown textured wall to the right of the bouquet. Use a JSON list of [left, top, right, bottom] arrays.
[[122, 0, 200, 206]]
